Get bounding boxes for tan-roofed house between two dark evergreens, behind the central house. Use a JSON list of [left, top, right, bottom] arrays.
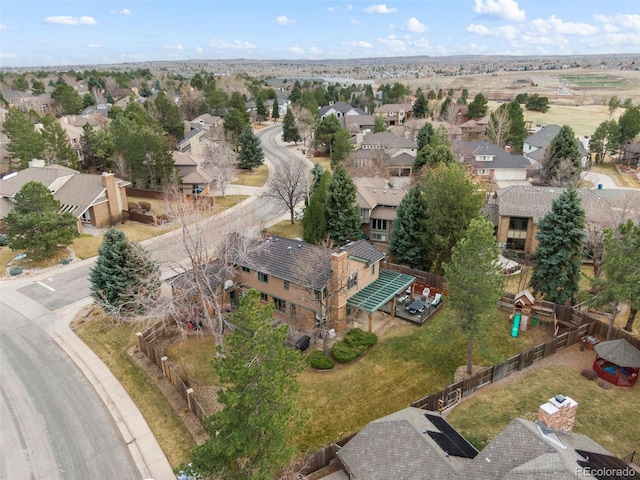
[[354, 178, 407, 251]]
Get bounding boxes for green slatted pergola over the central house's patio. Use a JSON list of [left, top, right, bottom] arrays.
[[347, 268, 416, 331]]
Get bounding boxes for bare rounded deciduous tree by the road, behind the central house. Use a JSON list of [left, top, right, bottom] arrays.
[[261, 158, 309, 225]]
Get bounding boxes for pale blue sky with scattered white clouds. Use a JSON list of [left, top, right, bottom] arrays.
[[0, 0, 640, 67]]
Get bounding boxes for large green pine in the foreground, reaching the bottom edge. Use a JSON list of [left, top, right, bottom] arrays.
[[192, 290, 305, 480]]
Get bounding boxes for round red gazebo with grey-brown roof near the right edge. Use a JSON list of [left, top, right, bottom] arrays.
[[593, 339, 640, 387]]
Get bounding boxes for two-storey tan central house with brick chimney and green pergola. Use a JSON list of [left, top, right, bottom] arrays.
[[236, 237, 415, 333]]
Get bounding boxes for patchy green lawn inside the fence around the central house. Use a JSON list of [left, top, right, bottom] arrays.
[[168, 306, 550, 451]]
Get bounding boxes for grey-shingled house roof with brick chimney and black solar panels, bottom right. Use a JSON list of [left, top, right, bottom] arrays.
[[331, 395, 637, 480]]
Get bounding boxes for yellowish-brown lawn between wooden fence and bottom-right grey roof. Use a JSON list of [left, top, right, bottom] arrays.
[[448, 366, 640, 456]]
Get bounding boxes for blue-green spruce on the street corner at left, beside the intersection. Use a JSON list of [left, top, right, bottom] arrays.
[[89, 228, 161, 316]]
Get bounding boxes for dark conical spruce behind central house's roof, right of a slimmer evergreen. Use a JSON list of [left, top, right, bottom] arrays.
[[326, 163, 362, 245]]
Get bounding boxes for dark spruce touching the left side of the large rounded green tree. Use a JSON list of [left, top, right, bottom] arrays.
[[389, 184, 426, 267]]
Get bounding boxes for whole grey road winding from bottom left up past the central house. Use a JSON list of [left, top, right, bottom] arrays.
[[0, 125, 311, 480]]
